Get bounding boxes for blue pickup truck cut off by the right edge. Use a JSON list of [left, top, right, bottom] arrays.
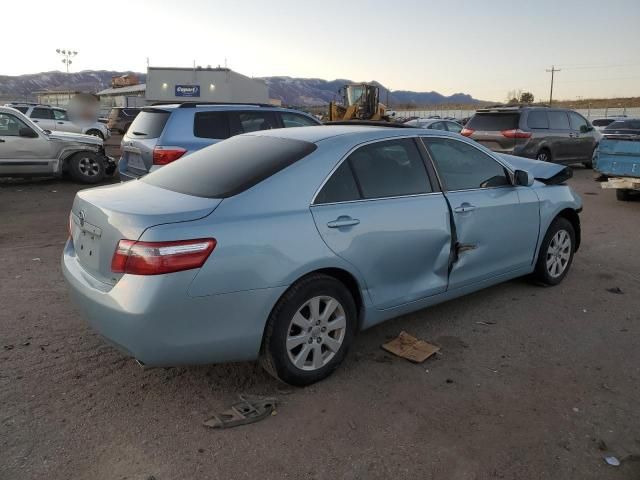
[[593, 121, 640, 201]]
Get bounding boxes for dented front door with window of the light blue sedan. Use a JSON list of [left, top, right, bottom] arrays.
[[424, 138, 539, 290]]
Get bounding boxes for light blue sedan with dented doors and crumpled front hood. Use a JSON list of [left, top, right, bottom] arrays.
[[62, 125, 582, 385]]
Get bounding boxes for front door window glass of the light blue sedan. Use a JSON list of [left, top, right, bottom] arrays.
[[422, 137, 511, 191]]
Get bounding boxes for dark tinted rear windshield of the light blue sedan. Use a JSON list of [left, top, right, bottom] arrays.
[[142, 134, 317, 198]]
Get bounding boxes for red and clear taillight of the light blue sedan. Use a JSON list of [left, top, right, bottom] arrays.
[[111, 238, 216, 275]]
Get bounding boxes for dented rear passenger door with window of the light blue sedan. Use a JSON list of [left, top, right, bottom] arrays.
[[311, 139, 451, 309]]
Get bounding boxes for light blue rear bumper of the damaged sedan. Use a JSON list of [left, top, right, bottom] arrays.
[[62, 241, 286, 366]]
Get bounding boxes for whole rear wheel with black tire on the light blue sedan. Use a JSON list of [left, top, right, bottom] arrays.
[[260, 274, 358, 386]]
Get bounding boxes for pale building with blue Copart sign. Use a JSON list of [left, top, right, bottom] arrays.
[[145, 67, 269, 103]]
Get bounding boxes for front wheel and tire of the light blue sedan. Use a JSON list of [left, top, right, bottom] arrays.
[[533, 217, 576, 285]]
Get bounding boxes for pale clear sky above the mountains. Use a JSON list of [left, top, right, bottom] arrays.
[[0, 0, 640, 101]]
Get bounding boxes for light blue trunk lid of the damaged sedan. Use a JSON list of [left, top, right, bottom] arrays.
[[70, 181, 221, 285]]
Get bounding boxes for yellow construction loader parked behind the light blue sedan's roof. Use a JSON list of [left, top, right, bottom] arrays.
[[329, 83, 390, 122]]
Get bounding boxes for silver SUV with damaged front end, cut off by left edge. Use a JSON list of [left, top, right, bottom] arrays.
[[0, 107, 116, 183]]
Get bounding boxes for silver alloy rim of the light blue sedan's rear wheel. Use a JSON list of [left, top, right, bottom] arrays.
[[286, 296, 347, 371]]
